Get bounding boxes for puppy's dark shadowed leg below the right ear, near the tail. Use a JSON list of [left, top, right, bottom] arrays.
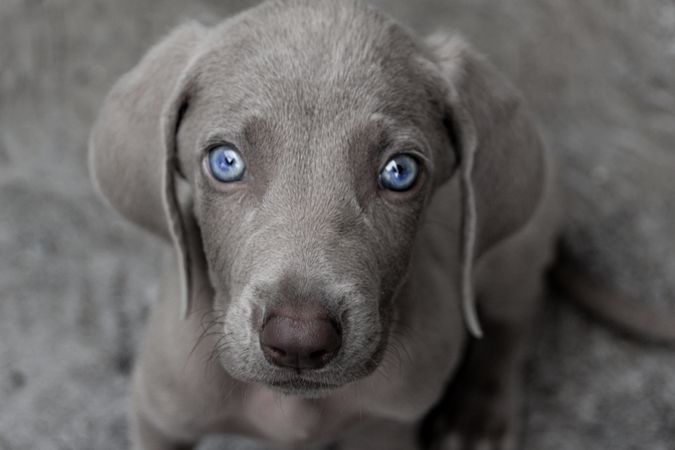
[[422, 232, 550, 450]]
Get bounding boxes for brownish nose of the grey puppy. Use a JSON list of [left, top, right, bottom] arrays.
[[260, 313, 342, 370]]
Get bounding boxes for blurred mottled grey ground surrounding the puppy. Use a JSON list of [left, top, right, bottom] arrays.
[[0, 0, 675, 450]]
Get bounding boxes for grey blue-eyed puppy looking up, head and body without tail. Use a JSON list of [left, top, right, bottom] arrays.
[[90, 0, 559, 450]]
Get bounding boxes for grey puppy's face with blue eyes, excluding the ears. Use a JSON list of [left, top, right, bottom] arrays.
[[177, 2, 454, 393]]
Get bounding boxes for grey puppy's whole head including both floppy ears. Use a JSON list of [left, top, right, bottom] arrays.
[[90, 0, 543, 395]]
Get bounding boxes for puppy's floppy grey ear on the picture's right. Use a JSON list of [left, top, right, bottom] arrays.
[[427, 35, 546, 337]]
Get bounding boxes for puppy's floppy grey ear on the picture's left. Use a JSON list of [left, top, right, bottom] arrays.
[[89, 23, 206, 316]]
